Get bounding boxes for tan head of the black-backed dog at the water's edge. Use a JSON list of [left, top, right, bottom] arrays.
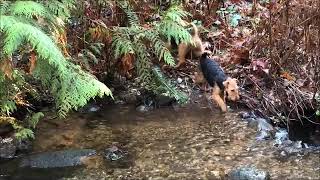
[[223, 77, 240, 101]]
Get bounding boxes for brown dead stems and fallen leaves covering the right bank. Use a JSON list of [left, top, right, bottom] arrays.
[[181, 0, 320, 123]]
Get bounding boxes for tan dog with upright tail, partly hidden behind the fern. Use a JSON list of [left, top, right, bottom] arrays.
[[166, 23, 205, 68]]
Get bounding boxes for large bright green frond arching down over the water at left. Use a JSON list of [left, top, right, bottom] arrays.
[[0, 16, 112, 116]]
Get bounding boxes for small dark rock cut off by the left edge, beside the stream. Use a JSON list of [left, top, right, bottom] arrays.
[[0, 137, 17, 159]]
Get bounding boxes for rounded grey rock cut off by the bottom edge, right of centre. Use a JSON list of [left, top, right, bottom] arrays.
[[228, 167, 270, 180]]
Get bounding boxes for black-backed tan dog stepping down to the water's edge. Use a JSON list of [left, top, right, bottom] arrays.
[[200, 52, 240, 112]]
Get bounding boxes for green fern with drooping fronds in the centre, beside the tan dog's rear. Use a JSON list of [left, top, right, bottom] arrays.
[[112, 1, 191, 103]]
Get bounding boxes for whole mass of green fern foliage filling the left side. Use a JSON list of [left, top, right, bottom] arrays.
[[0, 0, 112, 138]]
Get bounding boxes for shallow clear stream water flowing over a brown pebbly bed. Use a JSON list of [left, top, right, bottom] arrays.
[[8, 104, 320, 179]]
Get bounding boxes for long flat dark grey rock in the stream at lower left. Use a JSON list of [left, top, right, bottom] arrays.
[[19, 149, 96, 168]]
